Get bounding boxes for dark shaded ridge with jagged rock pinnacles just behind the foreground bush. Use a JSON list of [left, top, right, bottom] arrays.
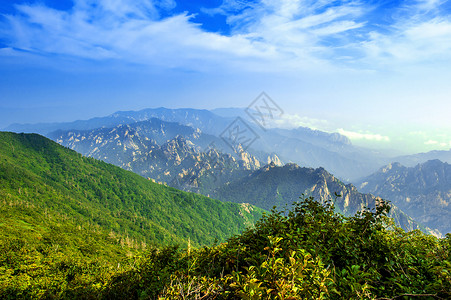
[[213, 164, 440, 235]]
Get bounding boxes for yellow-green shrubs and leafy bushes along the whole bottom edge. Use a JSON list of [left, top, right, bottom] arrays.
[[0, 198, 451, 299]]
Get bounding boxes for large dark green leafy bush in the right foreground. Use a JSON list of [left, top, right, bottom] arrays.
[[142, 198, 451, 299]]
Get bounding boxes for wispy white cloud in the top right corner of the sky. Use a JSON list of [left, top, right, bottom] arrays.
[[361, 0, 451, 64]]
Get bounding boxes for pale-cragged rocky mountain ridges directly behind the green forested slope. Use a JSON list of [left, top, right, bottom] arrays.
[[40, 118, 440, 235]]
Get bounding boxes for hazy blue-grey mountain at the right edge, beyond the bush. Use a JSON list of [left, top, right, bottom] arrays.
[[358, 160, 451, 234]]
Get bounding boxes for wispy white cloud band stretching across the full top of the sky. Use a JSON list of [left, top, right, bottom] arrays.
[[0, 0, 451, 70]]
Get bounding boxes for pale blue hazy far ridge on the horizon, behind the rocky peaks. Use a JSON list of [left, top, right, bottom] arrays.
[[7, 108, 388, 180]]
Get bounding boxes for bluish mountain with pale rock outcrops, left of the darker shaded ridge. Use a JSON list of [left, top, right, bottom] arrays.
[[49, 119, 281, 195]]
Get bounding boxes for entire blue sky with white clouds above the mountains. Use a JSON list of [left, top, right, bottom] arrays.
[[0, 0, 451, 152]]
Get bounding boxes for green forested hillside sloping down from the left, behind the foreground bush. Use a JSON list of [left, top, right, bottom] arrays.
[[0, 132, 262, 298]]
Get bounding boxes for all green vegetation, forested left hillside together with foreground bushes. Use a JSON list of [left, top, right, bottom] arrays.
[[0, 133, 451, 299]]
